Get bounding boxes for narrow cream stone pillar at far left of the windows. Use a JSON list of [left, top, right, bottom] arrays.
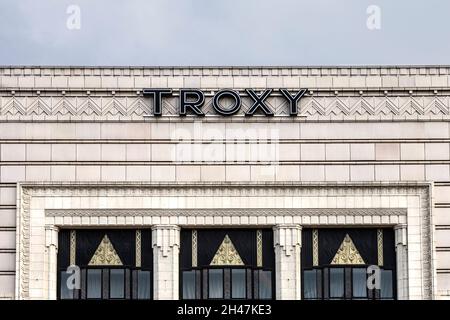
[[44, 225, 58, 300]]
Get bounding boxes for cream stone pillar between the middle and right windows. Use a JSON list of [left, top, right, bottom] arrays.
[[273, 224, 302, 300]]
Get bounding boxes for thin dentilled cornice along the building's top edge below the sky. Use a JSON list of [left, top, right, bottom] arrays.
[[0, 65, 450, 76]]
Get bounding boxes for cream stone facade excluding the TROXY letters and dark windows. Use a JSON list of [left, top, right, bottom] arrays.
[[0, 66, 450, 299]]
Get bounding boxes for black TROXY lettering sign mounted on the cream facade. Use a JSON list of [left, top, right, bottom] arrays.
[[142, 89, 306, 116]]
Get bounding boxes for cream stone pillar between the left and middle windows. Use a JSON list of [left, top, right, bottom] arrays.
[[152, 225, 180, 300]]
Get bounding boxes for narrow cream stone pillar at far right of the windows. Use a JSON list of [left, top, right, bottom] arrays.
[[394, 224, 409, 300]]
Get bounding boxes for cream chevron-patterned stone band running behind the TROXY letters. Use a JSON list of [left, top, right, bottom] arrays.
[[0, 96, 450, 120]]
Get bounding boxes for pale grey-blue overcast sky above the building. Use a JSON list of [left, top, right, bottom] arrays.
[[0, 0, 450, 66]]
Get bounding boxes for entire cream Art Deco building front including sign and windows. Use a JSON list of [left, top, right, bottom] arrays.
[[0, 66, 450, 300]]
